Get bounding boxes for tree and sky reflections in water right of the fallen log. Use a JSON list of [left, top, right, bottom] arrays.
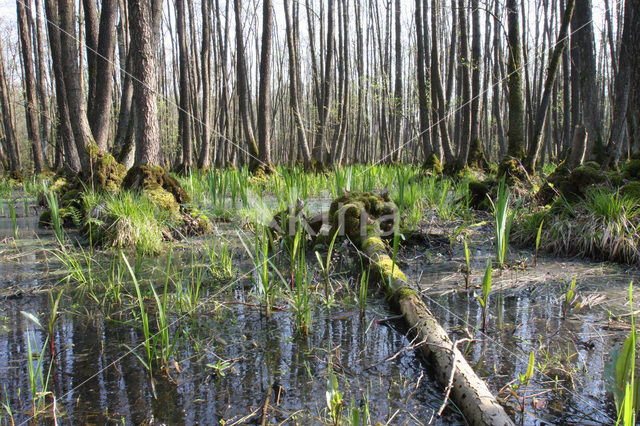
[[425, 286, 626, 424]]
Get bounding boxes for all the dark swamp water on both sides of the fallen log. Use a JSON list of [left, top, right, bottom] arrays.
[[0, 201, 639, 425]]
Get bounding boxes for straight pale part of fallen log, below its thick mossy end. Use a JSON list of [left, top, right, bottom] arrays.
[[333, 193, 513, 425]]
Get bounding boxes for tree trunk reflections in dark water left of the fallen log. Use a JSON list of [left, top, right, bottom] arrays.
[[0, 286, 460, 424]]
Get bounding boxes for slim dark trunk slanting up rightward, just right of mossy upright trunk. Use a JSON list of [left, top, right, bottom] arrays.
[[526, 0, 575, 172]]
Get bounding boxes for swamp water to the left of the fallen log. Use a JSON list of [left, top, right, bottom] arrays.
[[0, 206, 462, 425]]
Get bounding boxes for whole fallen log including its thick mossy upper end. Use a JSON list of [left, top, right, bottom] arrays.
[[330, 193, 514, 425]]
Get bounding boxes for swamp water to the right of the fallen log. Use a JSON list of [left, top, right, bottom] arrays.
[[401, 233, 640, 425]]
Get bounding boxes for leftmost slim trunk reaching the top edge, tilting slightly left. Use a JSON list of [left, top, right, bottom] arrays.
[[16, 0, 44, 173]]
